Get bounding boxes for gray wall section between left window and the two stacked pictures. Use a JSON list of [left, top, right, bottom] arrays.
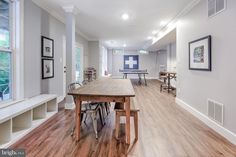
[[24, 0, 41, 98]]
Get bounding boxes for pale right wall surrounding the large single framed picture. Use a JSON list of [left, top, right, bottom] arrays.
[[177, 0, 236, 133]]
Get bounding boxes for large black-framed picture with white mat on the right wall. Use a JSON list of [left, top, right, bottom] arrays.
[[189, 36, 211, 71]]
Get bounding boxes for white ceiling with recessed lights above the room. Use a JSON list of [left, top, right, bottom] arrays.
[[33, 0, 193, 49]]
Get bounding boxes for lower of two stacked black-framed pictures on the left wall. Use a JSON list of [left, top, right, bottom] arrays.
[[42, 59, 54, 79]]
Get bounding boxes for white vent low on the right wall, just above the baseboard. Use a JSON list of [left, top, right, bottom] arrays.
[[207, 99, 224, 125]]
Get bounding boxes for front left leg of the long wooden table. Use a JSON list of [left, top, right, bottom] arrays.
[[76, 98, 82, 141]]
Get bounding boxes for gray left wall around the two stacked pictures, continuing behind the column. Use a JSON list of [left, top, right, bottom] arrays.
[[24, 0, 88, 98]]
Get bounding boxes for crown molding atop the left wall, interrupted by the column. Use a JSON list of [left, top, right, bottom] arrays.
[[32, 0, 91, 41]]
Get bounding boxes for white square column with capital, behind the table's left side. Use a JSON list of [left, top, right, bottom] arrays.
[[63, 6, 77, 109]]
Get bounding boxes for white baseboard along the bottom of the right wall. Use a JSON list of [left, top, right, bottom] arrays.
[[175, 98, 236, 145]]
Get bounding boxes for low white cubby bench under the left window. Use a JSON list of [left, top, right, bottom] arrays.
[[0, 94, 58, 148]]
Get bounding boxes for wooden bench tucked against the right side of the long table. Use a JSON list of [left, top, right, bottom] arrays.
[[114, 98, 139, 140]]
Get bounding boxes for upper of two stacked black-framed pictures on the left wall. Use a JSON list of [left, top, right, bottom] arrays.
[[41, 36, 54, 58]]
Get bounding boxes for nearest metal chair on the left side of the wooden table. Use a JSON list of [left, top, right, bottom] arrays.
[[68, 82, 104, 139]]
